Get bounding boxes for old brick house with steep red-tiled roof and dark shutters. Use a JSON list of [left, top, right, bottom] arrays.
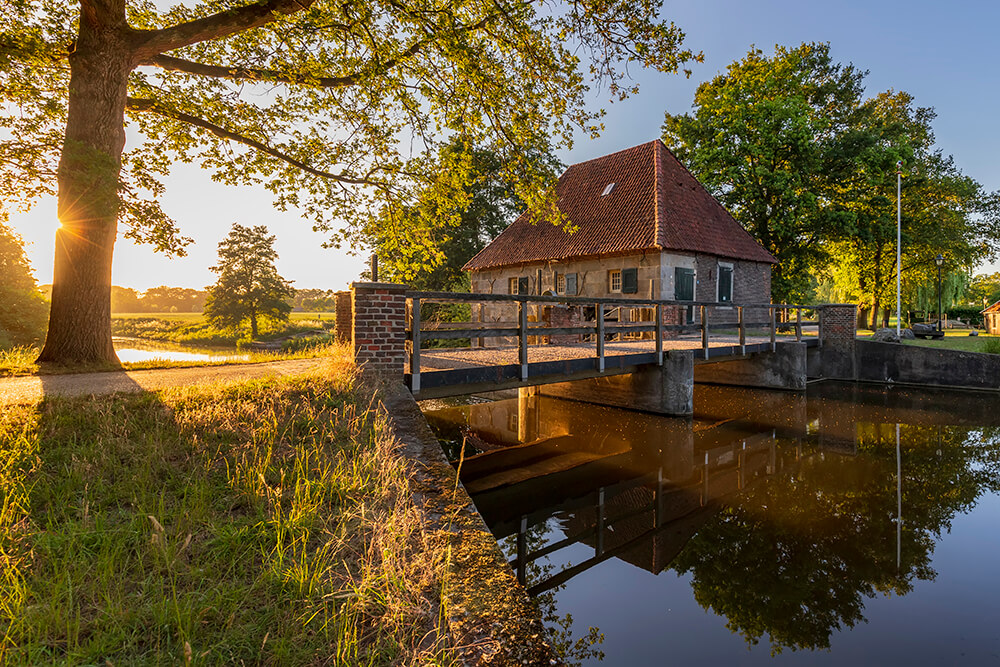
[[464, 139, 776, 336]]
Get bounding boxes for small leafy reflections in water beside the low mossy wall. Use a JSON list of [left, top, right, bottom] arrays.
[[499, 519, 604, 665]]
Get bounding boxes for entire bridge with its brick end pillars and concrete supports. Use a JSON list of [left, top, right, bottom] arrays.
[[337, 283, 854, 415]]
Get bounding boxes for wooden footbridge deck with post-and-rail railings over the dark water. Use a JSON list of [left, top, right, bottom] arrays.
[[404, 292, 821, 399]]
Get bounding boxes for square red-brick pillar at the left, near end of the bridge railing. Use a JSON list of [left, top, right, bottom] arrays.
[[351, 283, 407, 380]]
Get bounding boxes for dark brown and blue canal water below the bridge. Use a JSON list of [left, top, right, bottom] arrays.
[[423, 383, 1000, 666]]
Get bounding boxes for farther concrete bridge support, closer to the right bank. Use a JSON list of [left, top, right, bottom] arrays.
[[694, 343, 806, 391]]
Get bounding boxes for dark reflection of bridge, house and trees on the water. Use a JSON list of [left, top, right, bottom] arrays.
[[427, 385, 1000, 664]]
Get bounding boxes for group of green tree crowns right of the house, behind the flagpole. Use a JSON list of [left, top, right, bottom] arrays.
[[664, 43, 1000, 308]]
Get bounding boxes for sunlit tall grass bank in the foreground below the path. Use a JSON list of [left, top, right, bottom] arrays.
[[0, 349, 449, 665]]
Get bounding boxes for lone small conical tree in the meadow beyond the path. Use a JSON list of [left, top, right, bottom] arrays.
[[205, 224, 295, 337]]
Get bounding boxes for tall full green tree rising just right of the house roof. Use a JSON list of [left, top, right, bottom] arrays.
[[663, 43, 865, 301]]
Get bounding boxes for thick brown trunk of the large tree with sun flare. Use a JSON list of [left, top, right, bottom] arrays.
[[38, 0, 134, 364]]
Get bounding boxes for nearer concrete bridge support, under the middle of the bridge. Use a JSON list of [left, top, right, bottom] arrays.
[[522, 350, 694, 416]]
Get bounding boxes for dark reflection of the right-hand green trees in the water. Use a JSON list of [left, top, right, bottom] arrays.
[[672, 425, 1000, 654]]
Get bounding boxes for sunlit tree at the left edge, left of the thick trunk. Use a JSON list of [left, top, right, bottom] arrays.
[[0, 209, 48, 349]]
